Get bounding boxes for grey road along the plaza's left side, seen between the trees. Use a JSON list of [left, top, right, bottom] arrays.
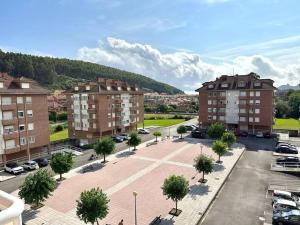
[[0, 119, 197, 193]]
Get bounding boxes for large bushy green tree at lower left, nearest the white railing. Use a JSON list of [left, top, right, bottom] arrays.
[[19, 170, 56, 207]]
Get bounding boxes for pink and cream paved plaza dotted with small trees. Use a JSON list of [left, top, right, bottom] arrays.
[[15, 138, 243, 225]]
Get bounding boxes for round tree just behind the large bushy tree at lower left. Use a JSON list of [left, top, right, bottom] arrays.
[[50, 152, 74, 180]]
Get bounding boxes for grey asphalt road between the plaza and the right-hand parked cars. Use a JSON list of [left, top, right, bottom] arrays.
[[198, 137, 299, 225]]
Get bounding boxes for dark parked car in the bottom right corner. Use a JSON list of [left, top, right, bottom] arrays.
[[272, 210, 300, 225]]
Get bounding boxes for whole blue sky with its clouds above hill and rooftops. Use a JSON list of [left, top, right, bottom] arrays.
[[0, 0, 300, 93]]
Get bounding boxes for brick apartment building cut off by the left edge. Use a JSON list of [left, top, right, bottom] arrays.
[[0, 73, 49, 164]]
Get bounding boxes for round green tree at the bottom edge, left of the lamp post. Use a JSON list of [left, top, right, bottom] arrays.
[[76, 188, 109, 224]]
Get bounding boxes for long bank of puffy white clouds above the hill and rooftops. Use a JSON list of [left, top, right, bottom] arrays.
[[78, 37, 300, 93]]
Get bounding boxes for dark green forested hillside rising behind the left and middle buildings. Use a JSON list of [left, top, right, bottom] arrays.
[[0, 50, 182, 94]]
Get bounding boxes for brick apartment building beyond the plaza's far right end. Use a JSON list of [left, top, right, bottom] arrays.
[[196, 73, 276, 133]]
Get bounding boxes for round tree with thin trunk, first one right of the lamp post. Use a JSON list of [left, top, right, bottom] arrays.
[[162, 175, 189, 215]]
